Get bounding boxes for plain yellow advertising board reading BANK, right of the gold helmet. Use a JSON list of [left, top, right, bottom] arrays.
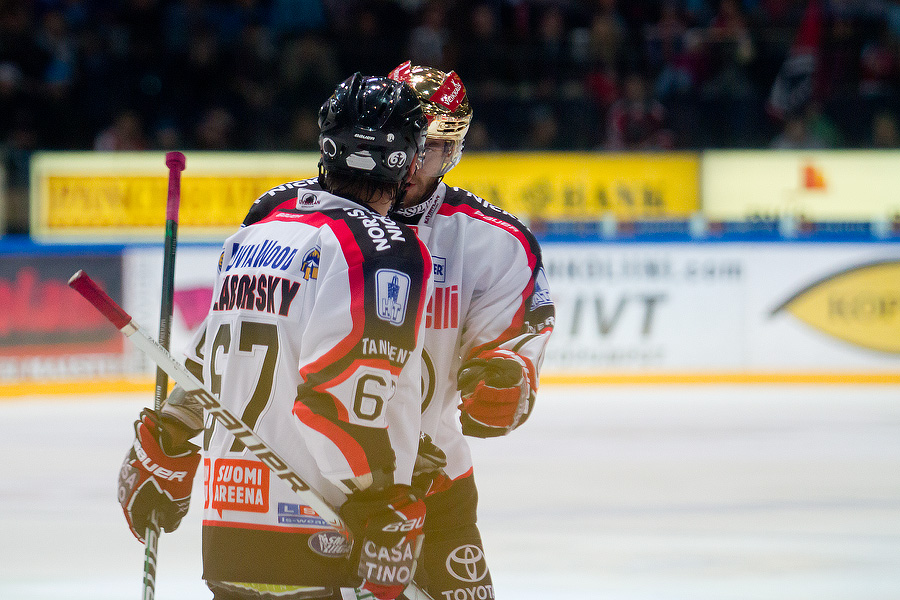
[[445, 153, 700, 221]]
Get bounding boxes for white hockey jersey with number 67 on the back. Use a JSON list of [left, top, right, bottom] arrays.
[[187, 184, 432, 583]]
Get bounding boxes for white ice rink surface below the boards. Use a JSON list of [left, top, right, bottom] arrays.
[[0, 385, 900, 600]]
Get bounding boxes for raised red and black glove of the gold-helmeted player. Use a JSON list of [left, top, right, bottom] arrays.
[[457, 348, 535, 438]]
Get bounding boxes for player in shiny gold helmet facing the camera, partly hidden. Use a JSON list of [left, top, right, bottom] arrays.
[[237, 62, 555, 598]]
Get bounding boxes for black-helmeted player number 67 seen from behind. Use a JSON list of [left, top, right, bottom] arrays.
[[119, 73, 433, 600]]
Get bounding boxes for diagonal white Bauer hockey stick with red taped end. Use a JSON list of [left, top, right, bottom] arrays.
[[69, 271, 433, 600]]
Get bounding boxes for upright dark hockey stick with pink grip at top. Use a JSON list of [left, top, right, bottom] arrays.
[[141, 152, 185, 600]]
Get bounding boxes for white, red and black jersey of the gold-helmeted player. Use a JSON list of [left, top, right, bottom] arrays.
[[244, 180, 555, 491]]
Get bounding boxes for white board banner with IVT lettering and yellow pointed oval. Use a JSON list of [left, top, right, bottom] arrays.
[[544, 243, 900, 380]]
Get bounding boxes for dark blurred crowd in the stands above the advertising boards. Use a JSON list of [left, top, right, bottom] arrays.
[[0, 0, 900, 232]]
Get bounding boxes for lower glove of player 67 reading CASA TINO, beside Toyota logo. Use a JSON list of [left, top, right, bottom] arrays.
[[341, 484, 425, 600]]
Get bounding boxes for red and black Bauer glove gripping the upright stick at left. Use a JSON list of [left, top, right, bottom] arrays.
[[118, 408, 200, 542]]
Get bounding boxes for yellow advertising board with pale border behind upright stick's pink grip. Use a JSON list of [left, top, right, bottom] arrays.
[[31, 152, 319, 243]]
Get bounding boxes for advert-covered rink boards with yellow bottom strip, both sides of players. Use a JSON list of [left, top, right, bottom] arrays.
[[0, 240, 900, 395]]
